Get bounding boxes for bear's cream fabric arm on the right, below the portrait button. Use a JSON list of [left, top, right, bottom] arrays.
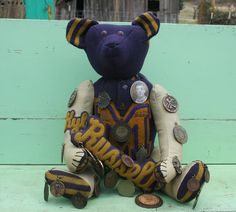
[[150, 85, 182, 183]]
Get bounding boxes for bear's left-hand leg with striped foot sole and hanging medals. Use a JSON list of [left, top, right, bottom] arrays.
[[44, 169, 99, 208]]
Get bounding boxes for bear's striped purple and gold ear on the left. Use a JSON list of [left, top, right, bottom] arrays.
[[66, 18, 98, 49]]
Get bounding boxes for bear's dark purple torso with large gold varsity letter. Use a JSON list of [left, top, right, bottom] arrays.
[[94, 74, 156, 160]]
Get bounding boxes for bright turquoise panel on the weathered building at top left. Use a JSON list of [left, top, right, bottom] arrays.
[[24, 0, 54, 19]]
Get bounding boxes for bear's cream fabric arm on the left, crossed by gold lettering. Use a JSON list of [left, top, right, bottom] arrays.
[[64, 80, 94, 172]]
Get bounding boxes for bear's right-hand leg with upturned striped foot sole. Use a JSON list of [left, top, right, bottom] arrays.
[[163, 161, 209, 203]]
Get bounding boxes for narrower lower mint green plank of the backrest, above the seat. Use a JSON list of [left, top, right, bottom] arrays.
[[0, 119, 236, 164]]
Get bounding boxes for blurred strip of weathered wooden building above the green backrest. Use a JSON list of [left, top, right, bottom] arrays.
[[0, 0, 236, 25]]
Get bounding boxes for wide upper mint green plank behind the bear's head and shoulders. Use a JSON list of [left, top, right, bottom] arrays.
[[0, 20, 236, 119]]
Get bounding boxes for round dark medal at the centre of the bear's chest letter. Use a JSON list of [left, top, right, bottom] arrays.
[[111, 122, 131, 143]]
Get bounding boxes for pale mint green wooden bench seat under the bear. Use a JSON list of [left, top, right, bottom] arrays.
[[0, 165, 236, 212]]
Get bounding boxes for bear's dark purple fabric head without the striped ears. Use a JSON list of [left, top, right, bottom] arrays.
[[85, 24, 149, 79]]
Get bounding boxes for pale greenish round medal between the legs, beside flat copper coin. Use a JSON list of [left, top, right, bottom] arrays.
[[117, 180, 135, 197]]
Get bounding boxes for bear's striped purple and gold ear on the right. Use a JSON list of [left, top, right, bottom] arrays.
[[132, 12, 160, 39]]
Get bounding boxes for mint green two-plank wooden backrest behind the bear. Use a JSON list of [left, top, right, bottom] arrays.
[[0, 20, 236, 164]]
